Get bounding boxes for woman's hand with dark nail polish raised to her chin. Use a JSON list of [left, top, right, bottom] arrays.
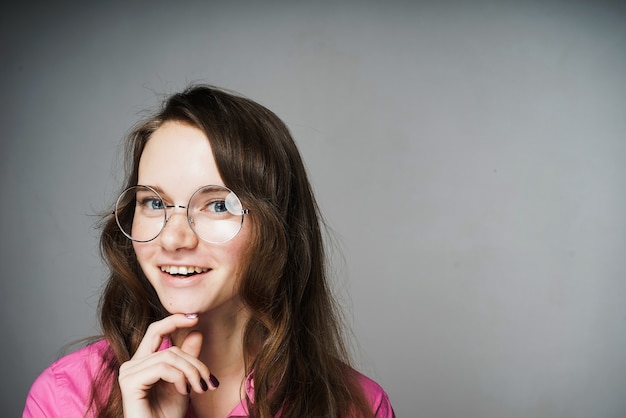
[[119, 314, 210, 418]]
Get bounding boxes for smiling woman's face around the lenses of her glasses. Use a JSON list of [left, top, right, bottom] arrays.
[[133, 122, 250, 313]]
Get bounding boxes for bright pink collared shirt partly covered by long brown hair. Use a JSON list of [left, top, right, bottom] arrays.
[[22, 340, 395, 418]]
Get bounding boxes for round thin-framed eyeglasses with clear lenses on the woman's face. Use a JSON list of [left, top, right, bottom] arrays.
[[115, 185, 249, 244]]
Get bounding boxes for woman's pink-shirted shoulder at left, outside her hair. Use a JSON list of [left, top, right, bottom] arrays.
[[23, 340, 109, 417]]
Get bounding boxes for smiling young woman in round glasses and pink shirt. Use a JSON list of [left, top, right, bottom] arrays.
[[24, 85, 395, 418]]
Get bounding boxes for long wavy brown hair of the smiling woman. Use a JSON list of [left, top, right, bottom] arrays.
[[92, 85, 373, 418]]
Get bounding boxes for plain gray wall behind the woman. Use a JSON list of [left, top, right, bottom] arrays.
[[0, 0, 626, 418]]
